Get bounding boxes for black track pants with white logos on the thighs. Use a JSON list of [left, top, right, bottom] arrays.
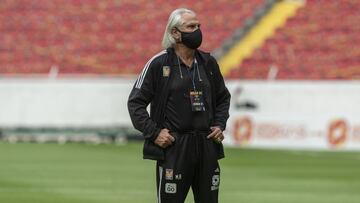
[[156, 133, 220, 203]]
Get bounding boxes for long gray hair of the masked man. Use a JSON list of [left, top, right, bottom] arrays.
[[161, 8, 196, 49]]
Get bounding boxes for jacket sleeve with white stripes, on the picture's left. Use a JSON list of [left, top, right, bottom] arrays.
[[128, 61, 160, 140]]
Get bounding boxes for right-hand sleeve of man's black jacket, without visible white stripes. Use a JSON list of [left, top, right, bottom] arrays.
[[212, 58, 231, 130]]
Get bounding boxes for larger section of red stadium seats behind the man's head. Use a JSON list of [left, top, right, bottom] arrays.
[[0, 0, 265, 74]]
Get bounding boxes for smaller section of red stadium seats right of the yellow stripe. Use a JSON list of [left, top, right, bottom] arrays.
[[228, 0, 360, 80]]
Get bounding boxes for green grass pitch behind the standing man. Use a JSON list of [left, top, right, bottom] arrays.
[[0, 142, 360, 203]]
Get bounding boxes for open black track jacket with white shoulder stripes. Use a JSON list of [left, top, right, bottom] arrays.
[[128, 48, 230, 160]]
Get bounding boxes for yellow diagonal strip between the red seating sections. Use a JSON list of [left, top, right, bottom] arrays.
[[219, 0, 304, 76]]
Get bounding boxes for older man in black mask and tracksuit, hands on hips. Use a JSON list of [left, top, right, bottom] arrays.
[[128, 8, 230, 203]]
